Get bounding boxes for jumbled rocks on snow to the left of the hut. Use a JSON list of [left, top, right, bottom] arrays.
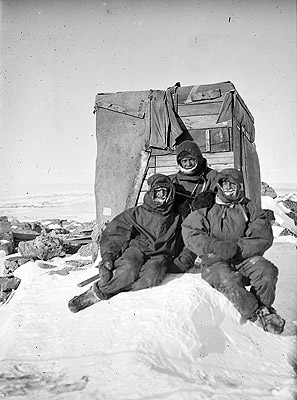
[[0, 216, 106, 304]]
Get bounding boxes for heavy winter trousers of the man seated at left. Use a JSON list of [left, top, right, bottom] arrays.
[[93, 247, 168, 300]]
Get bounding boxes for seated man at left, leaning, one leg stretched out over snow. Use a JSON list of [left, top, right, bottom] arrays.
[[68, 174, 184, 312]]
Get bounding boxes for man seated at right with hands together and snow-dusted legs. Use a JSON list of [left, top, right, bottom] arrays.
[[182, 168, 285, 334]]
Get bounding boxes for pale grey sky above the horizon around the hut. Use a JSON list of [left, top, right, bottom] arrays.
[[0, 0, 297, 186]]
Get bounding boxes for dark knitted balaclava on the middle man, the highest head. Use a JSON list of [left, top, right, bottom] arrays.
[[176, 140, 206, 175]]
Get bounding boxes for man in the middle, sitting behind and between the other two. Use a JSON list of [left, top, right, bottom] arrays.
[[170, 140, 217, 272]]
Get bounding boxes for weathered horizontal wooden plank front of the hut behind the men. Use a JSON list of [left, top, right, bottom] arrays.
[[138, 82, 234, 204]]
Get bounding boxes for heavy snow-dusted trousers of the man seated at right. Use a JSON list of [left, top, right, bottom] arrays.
[[201, 256, 278, 319]]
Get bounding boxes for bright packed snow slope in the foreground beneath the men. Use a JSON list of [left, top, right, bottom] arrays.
[[0, 242, 297, 400]]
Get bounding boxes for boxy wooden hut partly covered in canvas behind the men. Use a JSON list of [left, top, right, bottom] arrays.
[[94, 81, 261, 224]]
